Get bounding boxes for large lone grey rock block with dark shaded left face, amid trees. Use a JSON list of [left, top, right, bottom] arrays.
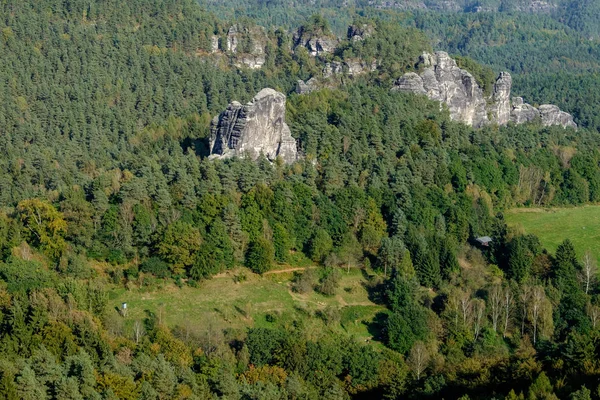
[[210, 88, 297, 163]]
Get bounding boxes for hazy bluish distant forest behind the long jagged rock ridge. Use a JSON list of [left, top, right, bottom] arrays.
[[200, 0, 600, 130]]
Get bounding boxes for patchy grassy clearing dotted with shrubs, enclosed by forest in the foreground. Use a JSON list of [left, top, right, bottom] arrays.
[[109, 268, 384, 339]]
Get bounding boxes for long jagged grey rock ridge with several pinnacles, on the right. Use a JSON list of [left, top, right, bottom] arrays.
[[392, 51, 577, 128]]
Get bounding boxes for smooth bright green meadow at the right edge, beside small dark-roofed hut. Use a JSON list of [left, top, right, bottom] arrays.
[[505, 206, 600, 261]]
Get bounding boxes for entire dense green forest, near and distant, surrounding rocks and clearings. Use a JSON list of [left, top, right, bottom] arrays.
[[0, 0, 600, 400]]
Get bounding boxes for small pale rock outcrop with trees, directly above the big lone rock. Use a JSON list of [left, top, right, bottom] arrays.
[[227, 25, 268, 69]]
